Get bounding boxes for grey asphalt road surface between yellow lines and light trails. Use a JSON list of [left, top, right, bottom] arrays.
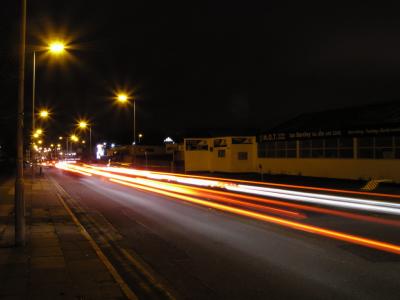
[[46, 169, 400, 299]]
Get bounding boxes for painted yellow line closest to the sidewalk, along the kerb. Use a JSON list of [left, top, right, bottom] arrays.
[[51, 179, 139, 300]]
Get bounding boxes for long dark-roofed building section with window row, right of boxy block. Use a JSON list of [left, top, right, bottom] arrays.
[[258, 101, 400, 182]]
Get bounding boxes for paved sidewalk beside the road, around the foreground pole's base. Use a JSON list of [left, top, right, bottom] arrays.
[[0, 177, 125, 299]]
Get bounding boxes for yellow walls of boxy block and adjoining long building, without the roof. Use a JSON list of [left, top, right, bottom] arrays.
[[184, 138, 400, 183]]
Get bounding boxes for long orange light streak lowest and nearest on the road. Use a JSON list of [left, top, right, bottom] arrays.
[[110, 178, 400, 255]]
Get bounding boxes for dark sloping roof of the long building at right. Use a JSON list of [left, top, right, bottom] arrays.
[[269, 100, 400, 132]]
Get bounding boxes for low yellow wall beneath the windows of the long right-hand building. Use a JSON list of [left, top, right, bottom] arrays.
[[254, 158, 400, 182]]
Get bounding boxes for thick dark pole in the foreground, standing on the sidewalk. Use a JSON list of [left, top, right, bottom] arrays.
[[14, 0, 26, 246]]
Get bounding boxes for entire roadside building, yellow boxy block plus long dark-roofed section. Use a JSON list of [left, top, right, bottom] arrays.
[[184, 101, 400, 182]]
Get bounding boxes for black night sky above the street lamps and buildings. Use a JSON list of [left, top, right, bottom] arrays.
[[0, 0, 400, 150]]
